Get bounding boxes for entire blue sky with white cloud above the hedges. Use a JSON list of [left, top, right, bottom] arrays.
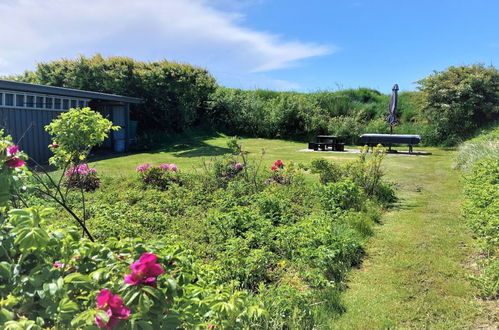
[[0, 0, 499, 93]]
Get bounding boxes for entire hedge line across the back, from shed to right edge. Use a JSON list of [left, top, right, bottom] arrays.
[[7, 55, 499, 147]]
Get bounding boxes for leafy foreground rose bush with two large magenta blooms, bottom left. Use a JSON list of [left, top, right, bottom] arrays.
[[0, 208, 265, 328]]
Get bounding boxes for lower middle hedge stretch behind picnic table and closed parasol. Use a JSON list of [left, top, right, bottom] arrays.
[[208, 87, 426, 143]]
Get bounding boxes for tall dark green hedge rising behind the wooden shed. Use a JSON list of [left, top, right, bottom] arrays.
[[16, 54, 215, 132]]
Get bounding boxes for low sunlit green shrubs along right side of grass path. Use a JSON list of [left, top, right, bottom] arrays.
[[457, 127, 499, 297]]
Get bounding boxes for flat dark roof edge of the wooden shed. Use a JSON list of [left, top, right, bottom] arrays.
[[0, 79, 143, 104]]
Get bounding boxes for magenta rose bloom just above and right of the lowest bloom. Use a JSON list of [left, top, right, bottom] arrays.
[[125, 252, 165, 286]]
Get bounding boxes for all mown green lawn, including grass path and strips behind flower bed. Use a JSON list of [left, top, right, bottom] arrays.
[[89, 135, 487, 329]]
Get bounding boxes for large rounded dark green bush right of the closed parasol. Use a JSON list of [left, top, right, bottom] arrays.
[[418, 64, 499, 145]]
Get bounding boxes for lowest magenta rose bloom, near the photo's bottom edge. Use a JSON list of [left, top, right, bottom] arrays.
[[95, 289, 131, 329]]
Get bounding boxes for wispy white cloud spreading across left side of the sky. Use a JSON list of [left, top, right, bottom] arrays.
[[0, 0, 335, 88]]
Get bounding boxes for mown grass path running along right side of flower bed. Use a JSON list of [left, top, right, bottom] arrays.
[[330, 150, 482, 329]]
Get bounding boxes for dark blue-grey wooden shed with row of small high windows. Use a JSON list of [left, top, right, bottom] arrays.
[[0, 80, 142, 162]]
